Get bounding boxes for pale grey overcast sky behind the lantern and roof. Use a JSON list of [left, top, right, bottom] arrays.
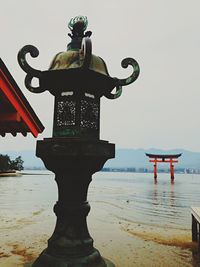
[[0, 0, 200, 151]]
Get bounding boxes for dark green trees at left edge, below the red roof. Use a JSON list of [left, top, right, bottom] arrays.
[[0, 154, 24, 172]]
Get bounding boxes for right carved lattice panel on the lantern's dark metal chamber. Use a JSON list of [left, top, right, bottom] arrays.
[[80, 100, 99, 130]]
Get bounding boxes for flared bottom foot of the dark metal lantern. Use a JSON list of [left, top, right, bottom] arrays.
[[24, 249, 115, 267]]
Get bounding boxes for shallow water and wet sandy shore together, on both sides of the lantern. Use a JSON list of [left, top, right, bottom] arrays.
[[0, 171, 200, 267]]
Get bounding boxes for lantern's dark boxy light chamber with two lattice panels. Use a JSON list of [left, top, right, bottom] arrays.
[[53, 91, 100, 139]]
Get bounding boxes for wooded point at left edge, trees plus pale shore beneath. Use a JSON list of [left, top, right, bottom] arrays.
[[0, 154, 24, 177]]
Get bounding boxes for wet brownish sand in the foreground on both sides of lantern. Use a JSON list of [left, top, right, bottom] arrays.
[[0, 203, 200, 267]]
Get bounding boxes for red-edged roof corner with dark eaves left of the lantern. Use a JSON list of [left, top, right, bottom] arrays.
[[0, 58, 44, 137]]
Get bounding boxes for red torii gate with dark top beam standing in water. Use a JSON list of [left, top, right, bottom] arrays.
[[146, 153, 182, 181]]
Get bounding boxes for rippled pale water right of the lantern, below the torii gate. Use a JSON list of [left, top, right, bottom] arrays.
[[90, 173, 200, 229]]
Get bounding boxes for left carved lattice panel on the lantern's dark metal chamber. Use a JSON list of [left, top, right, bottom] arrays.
[[56, 100, 76, 126]]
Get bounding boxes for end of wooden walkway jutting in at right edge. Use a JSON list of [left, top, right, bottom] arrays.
[[191, 207, 200, 249]]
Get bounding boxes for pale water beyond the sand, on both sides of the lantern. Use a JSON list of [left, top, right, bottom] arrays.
[[0, 172, 200, 229]]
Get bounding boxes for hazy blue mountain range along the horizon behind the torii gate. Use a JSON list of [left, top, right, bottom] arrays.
[[1, 148, 200, 169]]
